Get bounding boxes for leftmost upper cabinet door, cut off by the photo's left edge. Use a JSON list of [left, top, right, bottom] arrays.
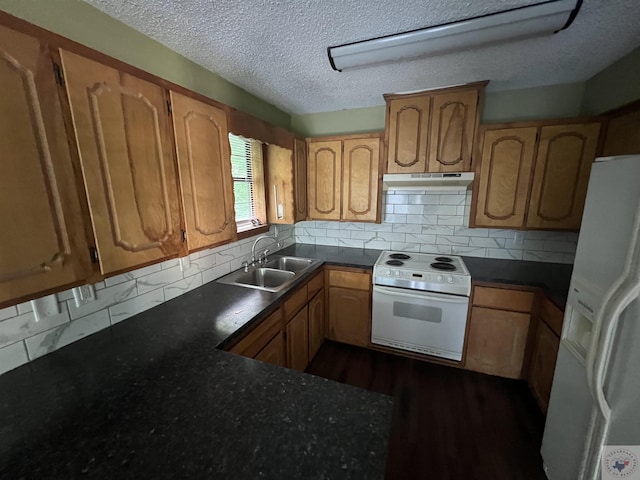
[[0, 26, 91, 306]]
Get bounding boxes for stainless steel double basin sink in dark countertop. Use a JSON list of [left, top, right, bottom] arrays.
[[218, 257, 321, 292]]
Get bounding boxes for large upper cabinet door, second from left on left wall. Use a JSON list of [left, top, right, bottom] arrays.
[[60, 50, 182, 274]]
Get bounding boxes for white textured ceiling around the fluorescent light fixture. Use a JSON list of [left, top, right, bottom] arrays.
[[85, 0, 640, 114]]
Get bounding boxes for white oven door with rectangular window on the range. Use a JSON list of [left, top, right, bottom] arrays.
[[371, 285, 469, 361]]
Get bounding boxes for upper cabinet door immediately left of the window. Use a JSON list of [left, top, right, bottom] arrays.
[[170, 92, 236, 250]]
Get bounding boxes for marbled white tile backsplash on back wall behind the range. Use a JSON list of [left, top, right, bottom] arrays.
[[295, 190, 578, 263]]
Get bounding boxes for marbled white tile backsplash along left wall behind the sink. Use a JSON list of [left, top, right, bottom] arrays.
[[0, 225, 294, 374]]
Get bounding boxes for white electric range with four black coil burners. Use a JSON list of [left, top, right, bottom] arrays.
[[371, 251, 471, 361]]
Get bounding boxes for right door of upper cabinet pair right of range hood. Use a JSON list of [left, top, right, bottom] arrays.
[[526, 123, 600, 230]]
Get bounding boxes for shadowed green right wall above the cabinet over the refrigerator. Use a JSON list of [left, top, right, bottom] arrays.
[[582, 48, 640, 115]]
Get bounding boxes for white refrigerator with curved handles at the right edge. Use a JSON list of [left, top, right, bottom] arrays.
[[541, 155, 640, 480]]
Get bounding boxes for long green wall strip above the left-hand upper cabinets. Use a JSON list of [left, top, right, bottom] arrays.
[[0, 0, 291, 128]]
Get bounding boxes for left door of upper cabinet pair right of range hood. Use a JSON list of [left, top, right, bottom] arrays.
[[475, 127, 538, 228]]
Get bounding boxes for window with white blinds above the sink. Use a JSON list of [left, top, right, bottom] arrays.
[[229, 134, 265, 232]]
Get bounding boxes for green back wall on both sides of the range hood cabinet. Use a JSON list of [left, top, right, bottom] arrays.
[[291, 83, 585, 137]]
